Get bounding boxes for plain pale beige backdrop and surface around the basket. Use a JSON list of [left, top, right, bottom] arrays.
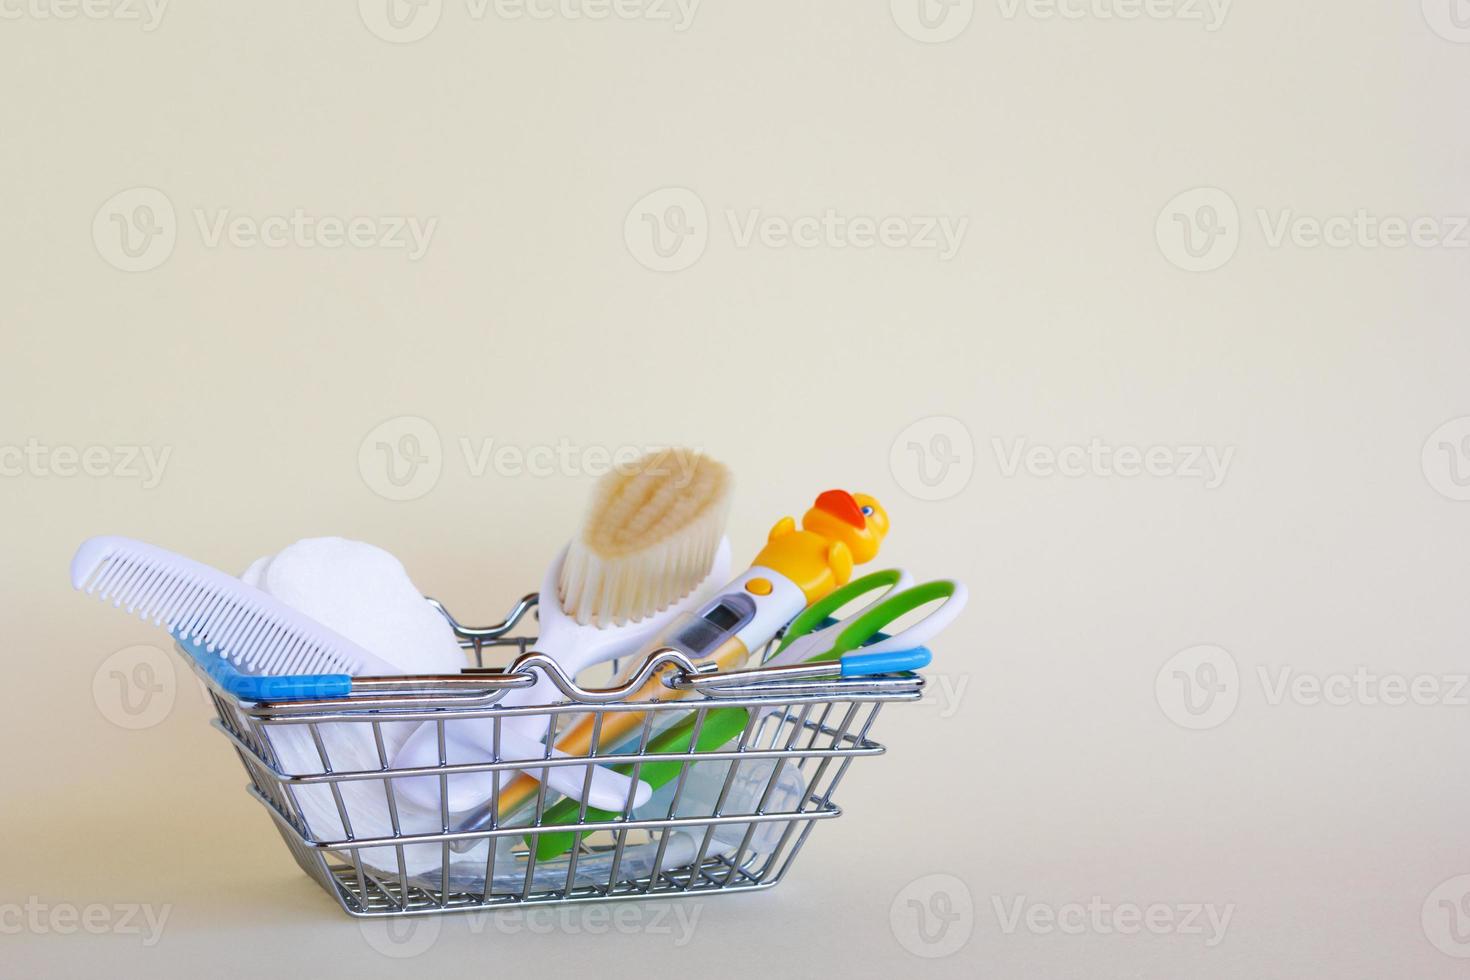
[[0, 0, 1470, 977]]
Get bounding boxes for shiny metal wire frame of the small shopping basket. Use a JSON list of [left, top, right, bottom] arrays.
[[182, 594, 923, 917]]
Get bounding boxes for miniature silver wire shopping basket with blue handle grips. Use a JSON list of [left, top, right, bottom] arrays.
[[182, 595, 923, 915]]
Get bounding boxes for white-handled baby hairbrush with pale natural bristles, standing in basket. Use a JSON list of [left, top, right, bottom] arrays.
[[394, 450, 732, 813]]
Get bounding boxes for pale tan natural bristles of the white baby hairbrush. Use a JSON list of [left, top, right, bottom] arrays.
[[557, 450, 731, 626]]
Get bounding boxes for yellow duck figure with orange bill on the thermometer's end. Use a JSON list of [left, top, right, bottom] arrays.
[[754, 491, 888, 605]]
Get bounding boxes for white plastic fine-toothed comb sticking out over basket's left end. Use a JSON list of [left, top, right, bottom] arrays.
[[72, 536, 400, 674]]
